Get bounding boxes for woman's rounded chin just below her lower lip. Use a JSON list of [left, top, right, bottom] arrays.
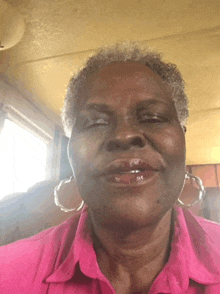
[[88, 195, 170, 233]]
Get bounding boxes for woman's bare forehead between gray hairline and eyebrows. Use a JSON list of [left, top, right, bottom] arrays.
[[86, 62, 172, 104]]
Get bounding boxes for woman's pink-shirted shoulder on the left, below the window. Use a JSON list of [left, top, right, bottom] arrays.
[[0, 214, 79, 293]]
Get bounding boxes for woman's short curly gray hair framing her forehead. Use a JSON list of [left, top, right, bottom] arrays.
[[62, 42, 188, 137]]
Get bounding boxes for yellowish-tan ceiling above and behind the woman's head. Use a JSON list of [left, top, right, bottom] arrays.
[[0, 0, 220, 164]]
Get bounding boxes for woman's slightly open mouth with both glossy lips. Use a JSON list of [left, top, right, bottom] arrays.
[[99, 158, 158, 186]]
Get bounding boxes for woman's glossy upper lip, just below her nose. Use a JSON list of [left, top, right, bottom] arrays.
[[100, 158, 158, 175]]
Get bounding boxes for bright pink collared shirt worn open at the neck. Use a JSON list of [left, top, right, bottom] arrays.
[[0, 208, 220, 294]]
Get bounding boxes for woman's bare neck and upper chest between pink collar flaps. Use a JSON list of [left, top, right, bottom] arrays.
[[89, 210, 174, 293]]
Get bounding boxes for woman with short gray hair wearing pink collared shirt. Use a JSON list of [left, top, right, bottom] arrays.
[[0, 44, 220, 294]]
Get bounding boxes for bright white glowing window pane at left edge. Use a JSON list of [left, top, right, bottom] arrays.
[[0, 119, 47, 201]]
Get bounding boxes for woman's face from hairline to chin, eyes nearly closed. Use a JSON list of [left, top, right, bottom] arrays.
[[68, 62, 185, 224]]
